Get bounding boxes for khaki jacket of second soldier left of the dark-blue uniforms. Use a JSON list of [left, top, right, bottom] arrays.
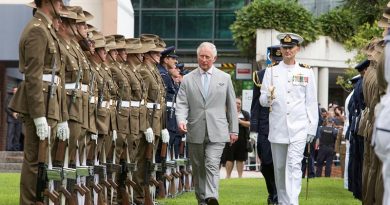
[[125, 64, 149, 135]]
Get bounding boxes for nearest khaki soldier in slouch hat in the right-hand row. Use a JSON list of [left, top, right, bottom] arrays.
[[363, 36, 386, 204]]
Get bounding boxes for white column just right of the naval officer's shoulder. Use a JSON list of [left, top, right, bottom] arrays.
[[318, 68, 329, 109]]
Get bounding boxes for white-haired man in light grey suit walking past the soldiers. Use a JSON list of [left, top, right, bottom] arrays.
[[176, 42, 238, 205]]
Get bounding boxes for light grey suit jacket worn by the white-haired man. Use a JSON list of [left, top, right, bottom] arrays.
[[176, 67, 238, 144]]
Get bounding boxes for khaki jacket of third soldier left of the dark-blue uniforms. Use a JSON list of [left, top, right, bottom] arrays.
[[109, 62, 131, 134]]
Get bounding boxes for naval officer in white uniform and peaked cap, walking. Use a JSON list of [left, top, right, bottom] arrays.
[[260, 33, 318, 205]]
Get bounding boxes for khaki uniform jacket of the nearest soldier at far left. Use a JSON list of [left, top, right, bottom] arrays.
[[9, 11, 69, 122]]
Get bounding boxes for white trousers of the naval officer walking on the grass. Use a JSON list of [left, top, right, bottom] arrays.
[[271, 140, 306, 205]]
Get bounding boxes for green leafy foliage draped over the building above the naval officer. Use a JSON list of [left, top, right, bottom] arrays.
[[230, 0, 320, 57]]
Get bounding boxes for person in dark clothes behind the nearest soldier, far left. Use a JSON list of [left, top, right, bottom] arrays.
[[5, 87, 22, 151]]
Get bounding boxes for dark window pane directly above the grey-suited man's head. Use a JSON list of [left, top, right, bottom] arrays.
[[178, 11, 213, 39]]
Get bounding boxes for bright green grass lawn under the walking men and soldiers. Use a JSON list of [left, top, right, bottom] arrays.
[[0, 173, 361, 205]]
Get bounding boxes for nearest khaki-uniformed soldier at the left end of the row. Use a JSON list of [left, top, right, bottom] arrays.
[[9, 0, 69, 205]]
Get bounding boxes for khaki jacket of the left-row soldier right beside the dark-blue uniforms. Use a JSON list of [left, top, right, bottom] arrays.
[[140, 63, 165, 136]]
